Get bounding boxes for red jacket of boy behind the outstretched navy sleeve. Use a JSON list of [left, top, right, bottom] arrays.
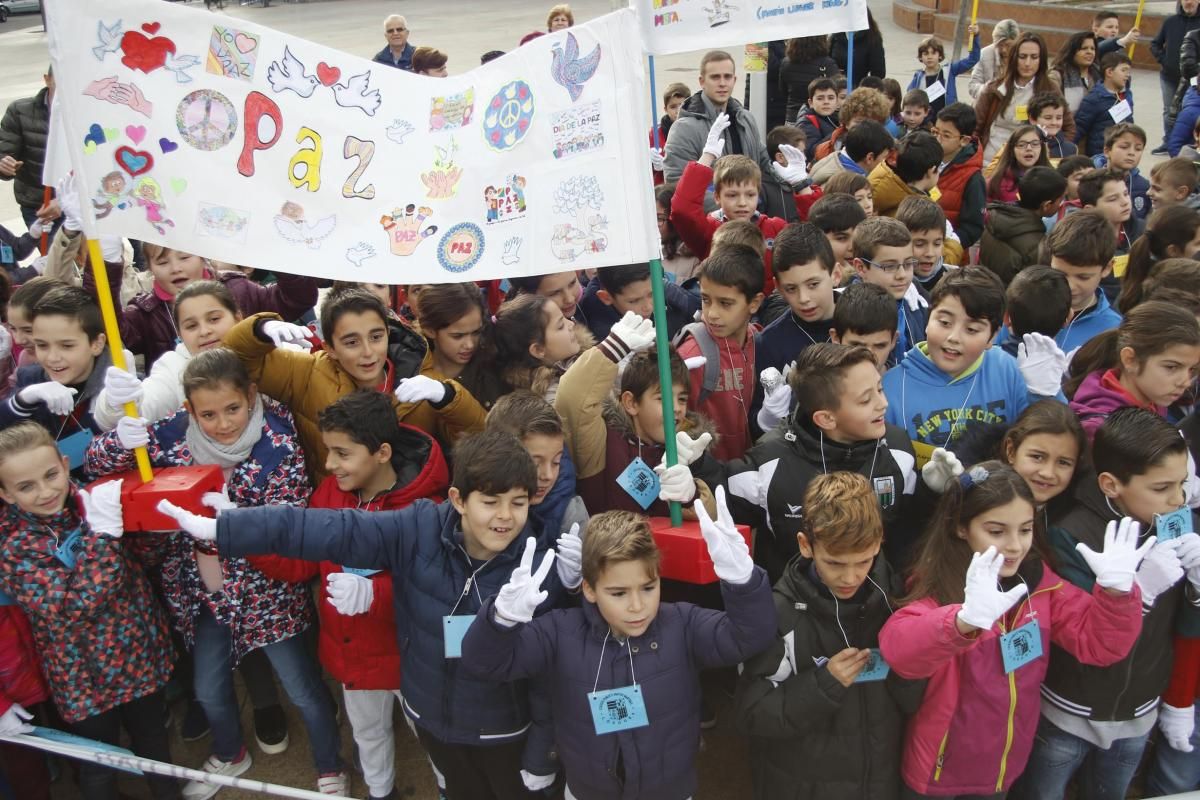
[[250, 426, 449, 690]]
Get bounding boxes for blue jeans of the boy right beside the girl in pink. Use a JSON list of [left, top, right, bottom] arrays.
[[1012, 717, 1150, 800]]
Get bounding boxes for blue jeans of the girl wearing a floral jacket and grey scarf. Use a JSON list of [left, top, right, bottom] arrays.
[[192, 607, 342, 774]]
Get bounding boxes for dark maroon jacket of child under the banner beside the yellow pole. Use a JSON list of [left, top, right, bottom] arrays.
[[83, 261, 317, 372]]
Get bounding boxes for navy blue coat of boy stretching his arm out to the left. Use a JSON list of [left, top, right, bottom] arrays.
[[217, 500, 563, 745]]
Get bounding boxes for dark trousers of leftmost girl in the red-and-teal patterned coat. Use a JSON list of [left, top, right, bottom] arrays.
[[69, 688, 179, 800]]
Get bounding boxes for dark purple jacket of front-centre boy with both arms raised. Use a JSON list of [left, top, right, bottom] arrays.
[[460, 567, 775, 800]]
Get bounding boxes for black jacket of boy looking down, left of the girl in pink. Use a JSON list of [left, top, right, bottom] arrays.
[[734, 555, 925, 800]]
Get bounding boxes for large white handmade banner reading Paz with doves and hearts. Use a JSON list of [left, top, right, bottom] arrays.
[[47, 0, 660, 283]]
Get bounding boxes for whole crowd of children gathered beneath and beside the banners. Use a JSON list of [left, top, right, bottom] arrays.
[[0, 9, 1200, 800]]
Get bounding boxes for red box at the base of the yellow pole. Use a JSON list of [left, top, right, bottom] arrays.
[[88, 464, 224, 531]]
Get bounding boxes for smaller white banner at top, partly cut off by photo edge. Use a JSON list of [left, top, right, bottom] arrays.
[[634, 0, 866, 55]]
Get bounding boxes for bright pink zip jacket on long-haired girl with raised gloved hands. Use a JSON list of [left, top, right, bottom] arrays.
[[880, 566, 1141, 795]]
